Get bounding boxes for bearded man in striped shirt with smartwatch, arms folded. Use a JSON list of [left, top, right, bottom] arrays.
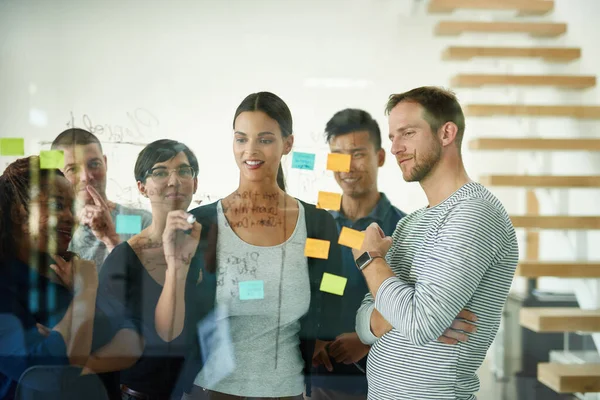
[[353, 87, 518, 399]]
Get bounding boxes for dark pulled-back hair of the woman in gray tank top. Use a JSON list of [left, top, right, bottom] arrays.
[[233, 92, 294, 192]]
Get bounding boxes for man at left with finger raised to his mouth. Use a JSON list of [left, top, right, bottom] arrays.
[[52, 128, 152, 271]]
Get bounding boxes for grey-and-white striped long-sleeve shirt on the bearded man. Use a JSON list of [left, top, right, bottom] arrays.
[[356, 183, 518, 400]]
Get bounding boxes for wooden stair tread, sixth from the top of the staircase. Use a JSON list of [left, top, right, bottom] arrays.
[[469, 138, 600, 151]]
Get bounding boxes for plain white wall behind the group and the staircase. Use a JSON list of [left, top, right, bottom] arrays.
[[0, 0, 600, 344]]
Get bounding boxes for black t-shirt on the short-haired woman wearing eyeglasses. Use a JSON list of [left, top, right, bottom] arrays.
[[100, 242, 189, 397]]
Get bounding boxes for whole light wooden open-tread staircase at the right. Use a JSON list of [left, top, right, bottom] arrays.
[[428, 0, 600, 393]]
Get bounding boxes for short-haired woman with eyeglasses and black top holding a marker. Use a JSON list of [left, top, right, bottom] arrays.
[[92, 139, 201, 400]]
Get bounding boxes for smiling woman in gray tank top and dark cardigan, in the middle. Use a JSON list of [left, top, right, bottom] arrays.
[[157, 92, 341, 400]]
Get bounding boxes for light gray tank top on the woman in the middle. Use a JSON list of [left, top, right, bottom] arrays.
[[194, 201, 310, 397]]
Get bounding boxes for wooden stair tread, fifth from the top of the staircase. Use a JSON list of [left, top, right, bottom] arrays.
[[463, 104, 600, 119]]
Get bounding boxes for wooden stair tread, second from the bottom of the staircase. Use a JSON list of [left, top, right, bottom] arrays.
[[519, 307, 600, 332]]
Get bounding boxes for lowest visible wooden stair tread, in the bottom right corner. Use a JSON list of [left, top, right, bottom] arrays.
[[538, 363, 600, 393]]
